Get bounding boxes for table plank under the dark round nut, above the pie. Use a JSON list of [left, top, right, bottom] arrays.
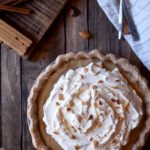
[[66, 0, 88, 52]]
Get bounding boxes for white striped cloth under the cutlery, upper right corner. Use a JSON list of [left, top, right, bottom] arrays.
[[97, 0, 150, 71]]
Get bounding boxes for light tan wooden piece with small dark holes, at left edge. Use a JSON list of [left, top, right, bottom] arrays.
[[0, 19, 32, 56]]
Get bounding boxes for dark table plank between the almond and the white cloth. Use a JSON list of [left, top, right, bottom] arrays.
[[88, 0, 120, 54]]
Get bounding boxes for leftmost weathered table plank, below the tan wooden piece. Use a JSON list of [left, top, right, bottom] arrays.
[[1, 44, 22, 150]]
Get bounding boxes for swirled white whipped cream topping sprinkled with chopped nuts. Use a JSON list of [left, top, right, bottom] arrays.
[[43, 63, 142, 150]]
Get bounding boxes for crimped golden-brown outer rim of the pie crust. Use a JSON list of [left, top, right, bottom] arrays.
[[27, 49, 150, 150]]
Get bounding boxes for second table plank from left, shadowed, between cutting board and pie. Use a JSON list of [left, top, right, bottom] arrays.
[[22, 13, 65, 150]]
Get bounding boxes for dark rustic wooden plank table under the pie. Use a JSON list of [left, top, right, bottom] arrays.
[[0, 0, 150, 150]]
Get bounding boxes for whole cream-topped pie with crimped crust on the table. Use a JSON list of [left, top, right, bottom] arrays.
[[28, 50, 150, 150]]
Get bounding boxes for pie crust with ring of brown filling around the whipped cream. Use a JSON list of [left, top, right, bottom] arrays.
[[27, 50, 150, 150]]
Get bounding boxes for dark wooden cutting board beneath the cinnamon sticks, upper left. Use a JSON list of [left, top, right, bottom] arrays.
[[0, 0, 67, 55]]
